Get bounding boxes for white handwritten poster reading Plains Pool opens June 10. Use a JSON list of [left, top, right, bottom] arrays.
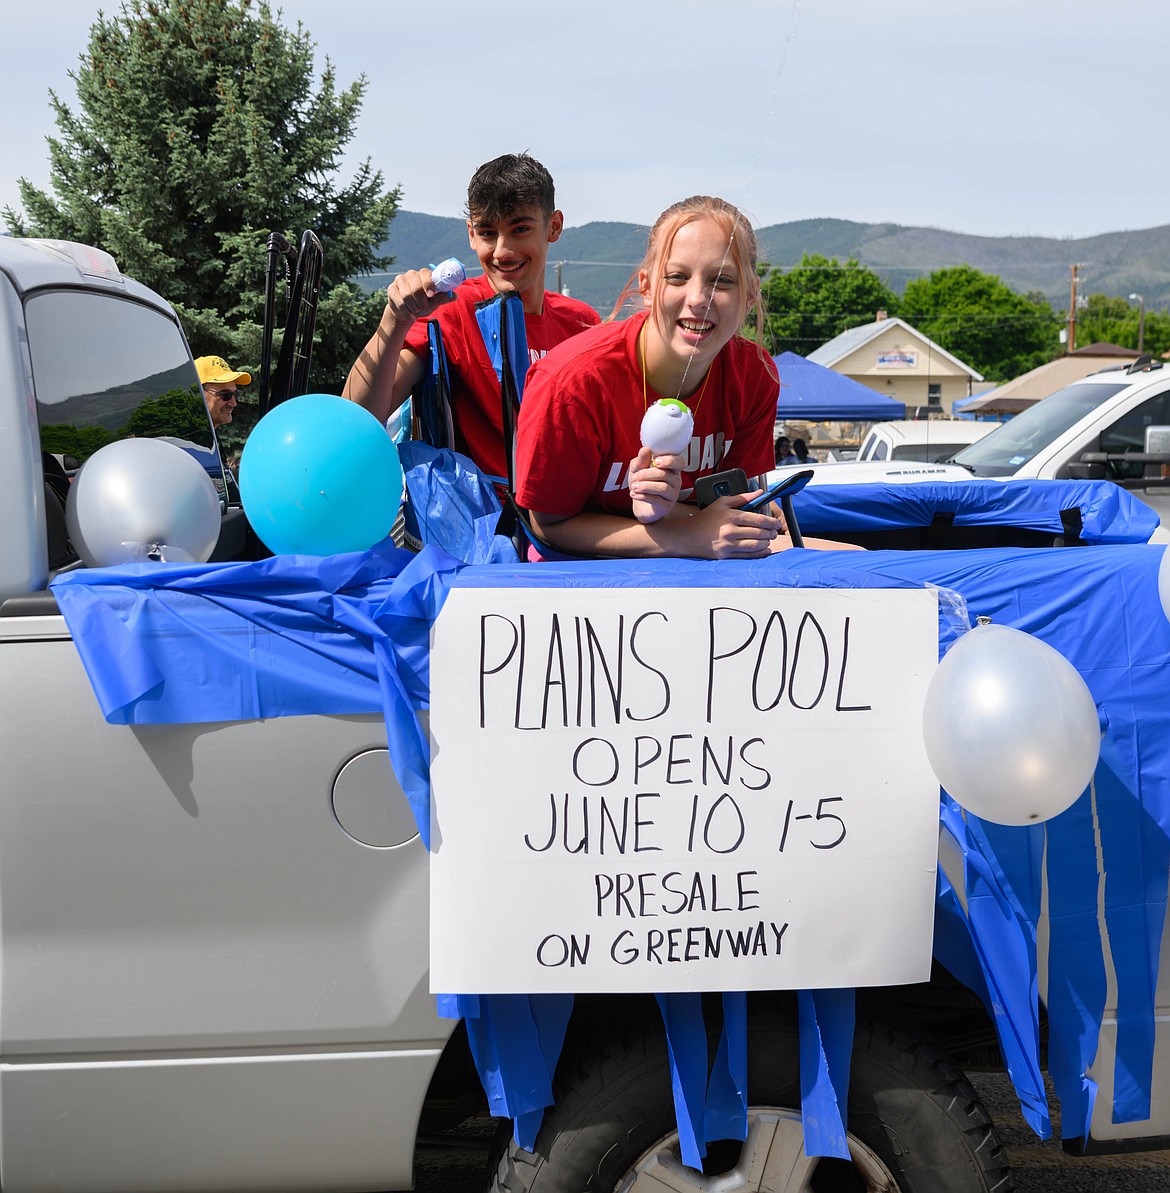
[[431, 588, 939, 994]]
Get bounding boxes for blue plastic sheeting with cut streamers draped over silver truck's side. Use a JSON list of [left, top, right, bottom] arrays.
[[54, 534, 1170, 1163]]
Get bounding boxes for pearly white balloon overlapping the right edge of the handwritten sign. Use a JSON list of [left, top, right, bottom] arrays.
[[922, 625, 1101, 824]]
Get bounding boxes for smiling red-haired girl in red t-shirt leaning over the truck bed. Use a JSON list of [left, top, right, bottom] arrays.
[[516, 196, 838, 558]]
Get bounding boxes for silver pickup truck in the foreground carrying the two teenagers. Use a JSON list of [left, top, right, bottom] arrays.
[[0, 239, 1170, 1193]]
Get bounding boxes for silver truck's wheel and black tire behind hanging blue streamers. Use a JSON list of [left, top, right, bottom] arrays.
[[491, 1018, 1014, 1193]]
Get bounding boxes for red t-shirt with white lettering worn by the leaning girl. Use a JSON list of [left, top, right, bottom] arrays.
[[516, 314, 780, 518]]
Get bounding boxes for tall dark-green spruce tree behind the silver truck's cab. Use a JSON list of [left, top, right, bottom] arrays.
[[5, 0, 398, 392]]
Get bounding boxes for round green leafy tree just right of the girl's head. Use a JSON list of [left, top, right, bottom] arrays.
[[761, 253, 898, 357]]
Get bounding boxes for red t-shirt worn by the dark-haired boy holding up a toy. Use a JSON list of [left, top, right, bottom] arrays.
[[406, 276, 599, 476]]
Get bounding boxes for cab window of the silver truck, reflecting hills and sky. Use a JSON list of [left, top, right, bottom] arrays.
[[25, 290, 223, 486]]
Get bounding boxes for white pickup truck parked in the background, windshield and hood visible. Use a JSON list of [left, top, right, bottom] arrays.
[[796, 357, 1170, 543]]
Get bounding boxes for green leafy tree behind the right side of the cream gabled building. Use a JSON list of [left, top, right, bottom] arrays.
[[902, 265, 1061, 381]]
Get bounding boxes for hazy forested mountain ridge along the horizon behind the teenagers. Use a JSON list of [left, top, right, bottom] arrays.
[[358, 211, 1170, 315]]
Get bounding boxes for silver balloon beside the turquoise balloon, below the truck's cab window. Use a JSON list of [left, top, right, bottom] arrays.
[[66, 439, 219, 568]]
